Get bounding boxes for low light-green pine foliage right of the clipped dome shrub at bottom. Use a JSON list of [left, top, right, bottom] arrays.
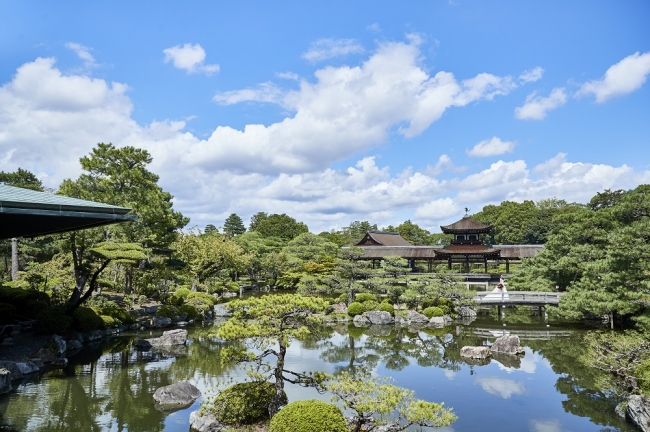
[[327, 372, 457, 430]]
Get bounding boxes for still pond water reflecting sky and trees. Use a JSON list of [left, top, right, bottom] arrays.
[[0, 313, 635, 432]]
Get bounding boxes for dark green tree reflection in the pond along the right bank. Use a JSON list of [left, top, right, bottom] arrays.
[[524, 331, 635, 431]]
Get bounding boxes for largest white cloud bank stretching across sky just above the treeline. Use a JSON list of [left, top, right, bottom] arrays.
[[0, 52, 650, 232]]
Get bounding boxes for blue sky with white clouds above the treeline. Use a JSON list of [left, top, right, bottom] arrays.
[[0, 0, 650, 233]]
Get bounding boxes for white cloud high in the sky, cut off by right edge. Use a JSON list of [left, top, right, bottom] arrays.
[[576, 52, 650, 103]]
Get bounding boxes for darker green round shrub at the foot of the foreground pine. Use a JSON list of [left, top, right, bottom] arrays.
[[208, 382, 287, 424]]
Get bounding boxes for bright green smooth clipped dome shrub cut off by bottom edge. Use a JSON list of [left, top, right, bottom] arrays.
[[269, 399, 348, 432]]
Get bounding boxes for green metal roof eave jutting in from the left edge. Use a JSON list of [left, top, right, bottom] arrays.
[[0, 184, 137, 239]]
